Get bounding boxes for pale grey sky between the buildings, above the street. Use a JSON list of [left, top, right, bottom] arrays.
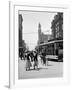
[[19, 11, 57, 50]]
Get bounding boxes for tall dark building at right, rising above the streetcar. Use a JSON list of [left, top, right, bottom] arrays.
[[51, 13, 63, 39]]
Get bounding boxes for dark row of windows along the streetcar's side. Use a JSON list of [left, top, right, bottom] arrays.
[[39, 42, 63, 55]]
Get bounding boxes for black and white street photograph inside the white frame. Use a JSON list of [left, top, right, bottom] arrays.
[[18, 10, 64, 80]]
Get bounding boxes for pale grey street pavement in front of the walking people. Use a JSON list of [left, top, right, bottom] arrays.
[[18, 60, 63, 79]]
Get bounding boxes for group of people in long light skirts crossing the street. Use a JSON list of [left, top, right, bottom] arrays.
[[19, 51, 46, 71]]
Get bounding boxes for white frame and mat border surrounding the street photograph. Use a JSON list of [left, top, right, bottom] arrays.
[[10, 2, 70, 87]]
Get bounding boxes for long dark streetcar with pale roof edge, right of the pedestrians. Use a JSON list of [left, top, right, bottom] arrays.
[[39, 39, 63, 62]]
